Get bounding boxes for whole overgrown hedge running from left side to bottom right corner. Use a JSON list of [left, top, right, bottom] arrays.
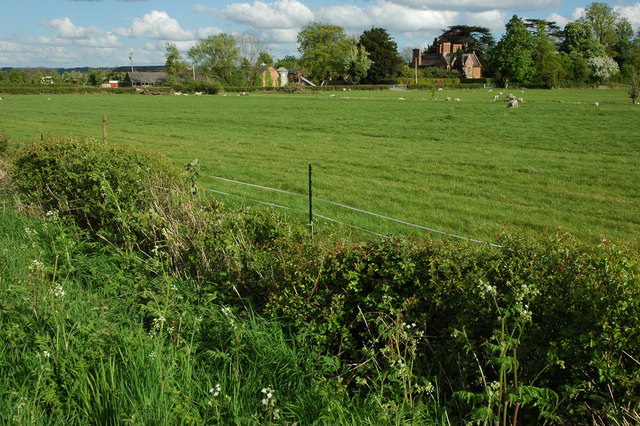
[[14, 139, 640, 424]]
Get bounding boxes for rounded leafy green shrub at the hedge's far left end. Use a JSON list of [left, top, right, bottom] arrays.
[[13, 138, 180, 248]]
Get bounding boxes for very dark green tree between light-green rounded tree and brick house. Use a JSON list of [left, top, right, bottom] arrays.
[[358, 28, 402, 84]]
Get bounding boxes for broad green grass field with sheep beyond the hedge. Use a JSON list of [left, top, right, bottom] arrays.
[[0, 89, 640, 245]]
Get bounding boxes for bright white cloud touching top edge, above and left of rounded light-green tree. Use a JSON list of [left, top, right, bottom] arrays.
[[219, 0, 314, 29]]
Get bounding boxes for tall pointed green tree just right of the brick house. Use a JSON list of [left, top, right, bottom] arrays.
[[493, 15, 535, 88]]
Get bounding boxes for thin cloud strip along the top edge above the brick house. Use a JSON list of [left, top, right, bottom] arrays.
[[382, 0, 561, 11]]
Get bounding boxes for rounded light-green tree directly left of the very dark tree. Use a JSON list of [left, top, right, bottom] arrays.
[[298, 22, 353, 81]]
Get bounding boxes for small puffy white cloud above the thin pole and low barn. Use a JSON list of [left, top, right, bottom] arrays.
[[114, 10, 194, 40]]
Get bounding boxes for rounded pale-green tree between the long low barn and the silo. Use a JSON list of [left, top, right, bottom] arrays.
[[188, 33, 240, 85]]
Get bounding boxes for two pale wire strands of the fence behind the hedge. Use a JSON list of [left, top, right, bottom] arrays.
[[202, 171, 502, 248]]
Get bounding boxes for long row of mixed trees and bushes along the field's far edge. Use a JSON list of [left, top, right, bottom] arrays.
[[0, 2, 640, 87]]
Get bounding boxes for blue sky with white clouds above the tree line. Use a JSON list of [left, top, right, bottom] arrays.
[[0, 0, 640, 68]]
